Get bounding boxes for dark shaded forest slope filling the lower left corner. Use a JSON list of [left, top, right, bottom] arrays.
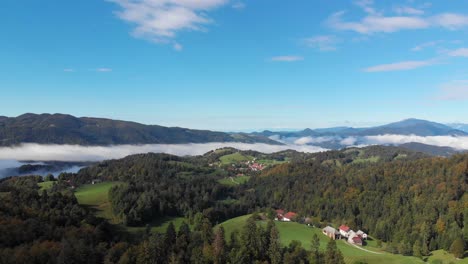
[[0, 177, 121, 264]]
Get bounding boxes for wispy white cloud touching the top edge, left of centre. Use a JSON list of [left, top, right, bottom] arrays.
[[108, 0, 228, 43]]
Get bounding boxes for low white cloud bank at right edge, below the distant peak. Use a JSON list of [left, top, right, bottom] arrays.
[[365, 135, 468, 150]]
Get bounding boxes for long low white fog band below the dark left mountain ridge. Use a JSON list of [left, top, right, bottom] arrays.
[[0, 142, 326, 161]]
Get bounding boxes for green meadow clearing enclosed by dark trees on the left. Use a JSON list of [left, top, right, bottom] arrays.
[[75, 182, 121, 223]]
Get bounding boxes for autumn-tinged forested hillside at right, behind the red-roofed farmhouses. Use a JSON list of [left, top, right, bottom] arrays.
[[247, 155, 468, 256]]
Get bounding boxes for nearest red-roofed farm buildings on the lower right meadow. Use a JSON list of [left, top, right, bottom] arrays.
[[274, 209, 368, 246]]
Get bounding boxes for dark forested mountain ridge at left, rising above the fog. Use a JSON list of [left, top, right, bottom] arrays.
[[0, 114, 280, 146]]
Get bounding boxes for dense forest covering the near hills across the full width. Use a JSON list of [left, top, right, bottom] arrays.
[[0, 146, 468, 263]]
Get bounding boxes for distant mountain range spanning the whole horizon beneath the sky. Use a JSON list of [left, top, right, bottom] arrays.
[[0, 114, 468, 156]]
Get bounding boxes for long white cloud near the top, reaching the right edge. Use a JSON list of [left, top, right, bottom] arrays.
[[327, 11, 468, 34]]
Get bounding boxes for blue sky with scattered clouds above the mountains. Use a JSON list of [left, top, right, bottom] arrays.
[[0, 0, 468, 131]]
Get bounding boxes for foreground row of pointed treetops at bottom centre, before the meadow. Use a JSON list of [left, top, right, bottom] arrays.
[[114, 216, 344, 264]]
